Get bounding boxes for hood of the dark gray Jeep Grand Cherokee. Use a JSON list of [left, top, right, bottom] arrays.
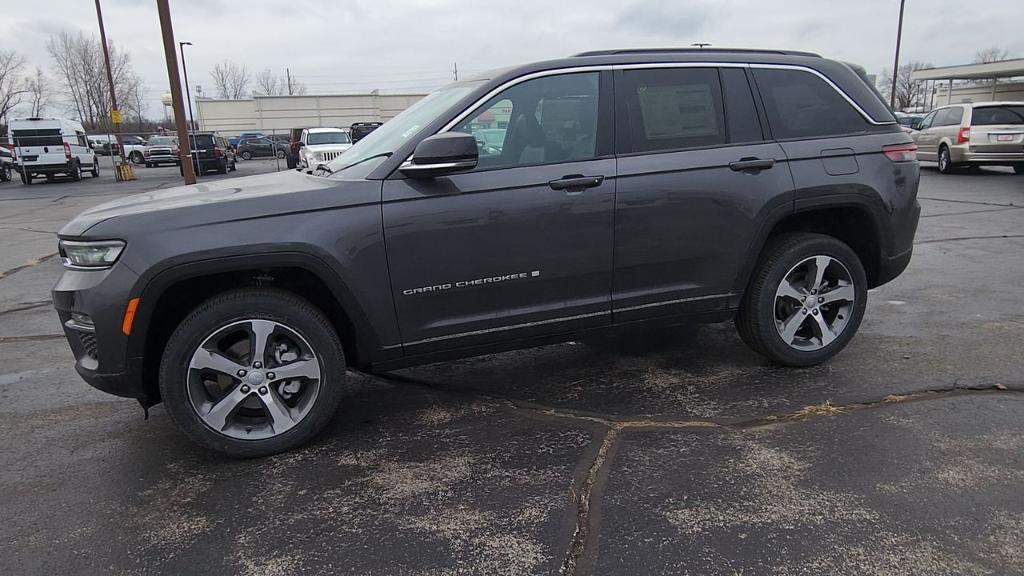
[[58, 170, 337, 237]]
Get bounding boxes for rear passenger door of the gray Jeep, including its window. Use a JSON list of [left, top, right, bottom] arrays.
[[612, 67, 793, 322]]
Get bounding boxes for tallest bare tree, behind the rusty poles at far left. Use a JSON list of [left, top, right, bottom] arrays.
[[46, 32, 142, 130]]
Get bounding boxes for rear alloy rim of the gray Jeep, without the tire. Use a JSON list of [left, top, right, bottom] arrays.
[[775, 255, 856, 352]]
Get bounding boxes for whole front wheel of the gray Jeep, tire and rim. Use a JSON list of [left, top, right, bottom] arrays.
[[160, 289, 348, 458]]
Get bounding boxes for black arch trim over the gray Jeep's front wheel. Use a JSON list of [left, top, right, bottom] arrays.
[[127, 245, 387, 361]]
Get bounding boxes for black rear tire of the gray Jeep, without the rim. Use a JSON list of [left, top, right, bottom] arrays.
[[735, 233, 867, 367]]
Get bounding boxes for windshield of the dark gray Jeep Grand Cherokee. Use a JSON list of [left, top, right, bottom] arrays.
[[328, 80, 483, 172]]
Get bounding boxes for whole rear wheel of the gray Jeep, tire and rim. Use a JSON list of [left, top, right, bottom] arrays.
[[736, 233, 867, 366]]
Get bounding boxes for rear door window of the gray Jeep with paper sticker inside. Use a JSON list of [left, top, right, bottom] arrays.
[[620, 68, 726, 152]]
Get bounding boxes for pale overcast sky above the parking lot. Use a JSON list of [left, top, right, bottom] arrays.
[[0, 0, 1024, 115]]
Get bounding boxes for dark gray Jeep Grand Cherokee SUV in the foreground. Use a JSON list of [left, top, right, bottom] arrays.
[[53, 49, 920, 456]]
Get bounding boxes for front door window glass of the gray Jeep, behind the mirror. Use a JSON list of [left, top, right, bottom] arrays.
[[455, 72, 600, 170]]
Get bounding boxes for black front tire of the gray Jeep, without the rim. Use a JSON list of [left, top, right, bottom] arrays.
[[160, 288, 350, 458]]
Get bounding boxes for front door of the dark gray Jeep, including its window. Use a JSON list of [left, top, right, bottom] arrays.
[[383, 72, 615, 354]]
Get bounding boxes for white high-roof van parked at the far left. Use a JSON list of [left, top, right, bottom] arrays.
[[7, 118, 99, 184]]
